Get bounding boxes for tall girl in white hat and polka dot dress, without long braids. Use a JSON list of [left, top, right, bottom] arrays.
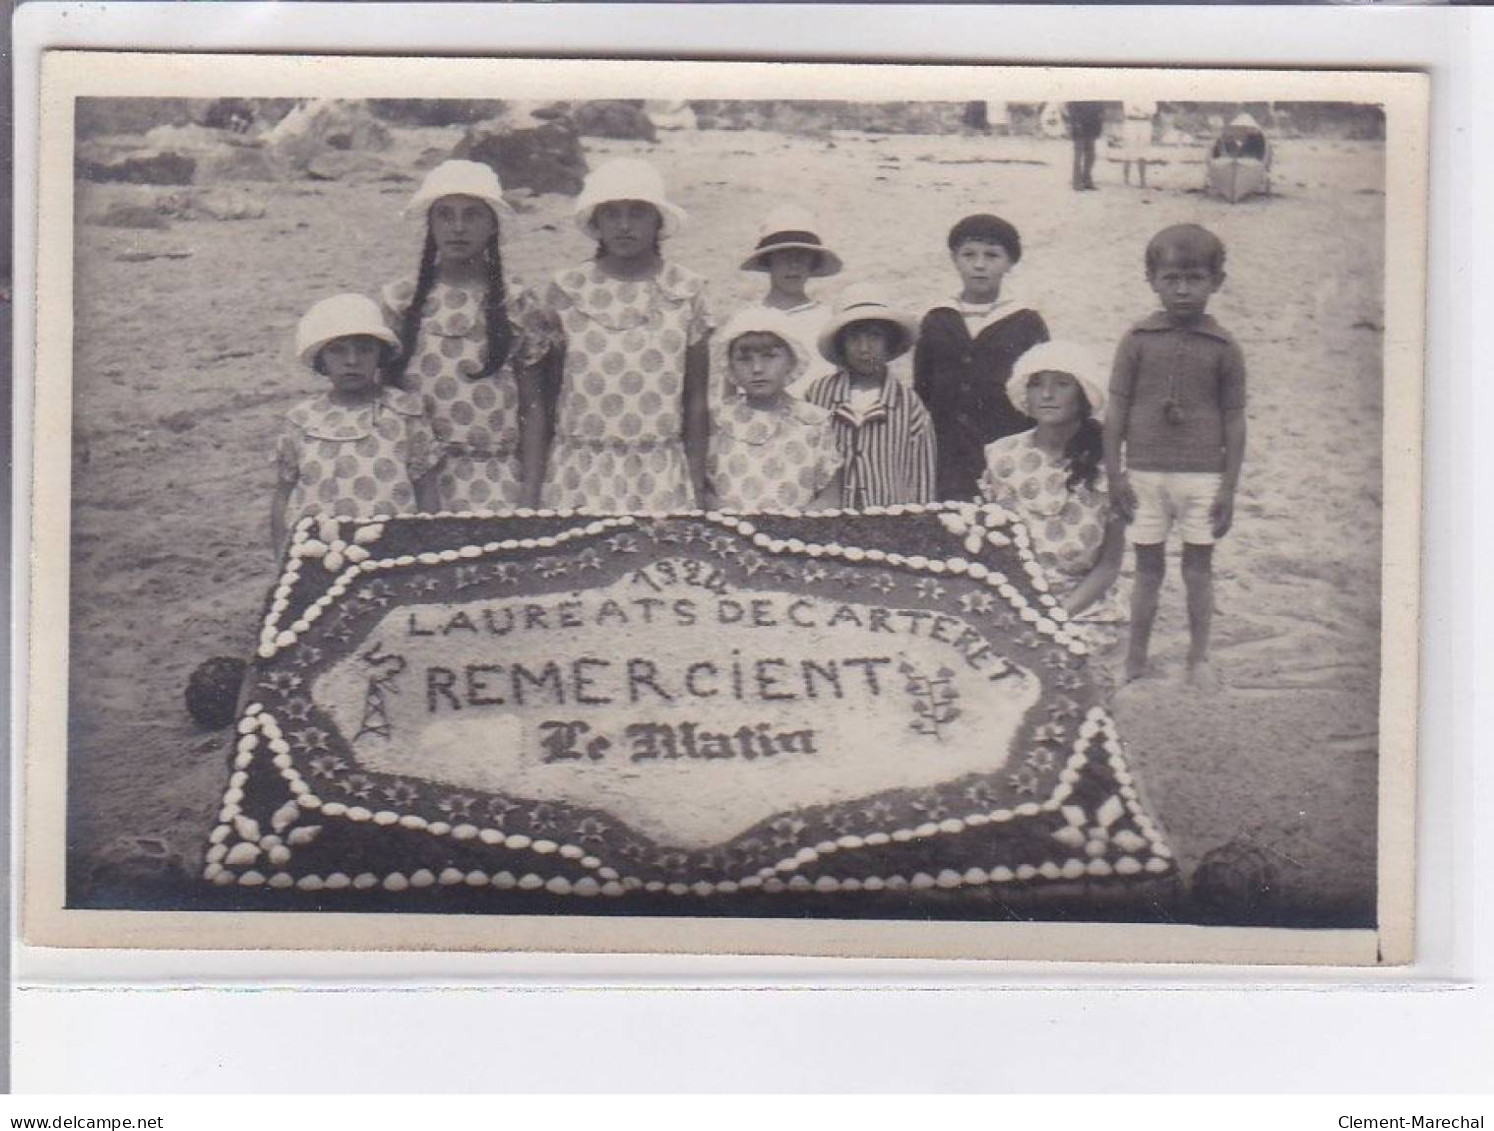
[[544, 158, 711, 512]]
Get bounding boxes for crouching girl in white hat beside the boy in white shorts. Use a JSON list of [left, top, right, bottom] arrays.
[[980, 342, 1125, 647]]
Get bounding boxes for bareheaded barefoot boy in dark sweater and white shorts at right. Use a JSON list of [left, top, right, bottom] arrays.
[[1106, 224, 1245, 689]]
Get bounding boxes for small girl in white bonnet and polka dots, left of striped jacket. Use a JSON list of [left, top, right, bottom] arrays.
[[707, 309, 841, 511]]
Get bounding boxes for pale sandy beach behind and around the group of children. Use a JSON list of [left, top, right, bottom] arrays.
[[64, 118, 1385, 926]]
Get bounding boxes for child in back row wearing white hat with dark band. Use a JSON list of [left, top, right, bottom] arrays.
[[743, 205, 843, 396]]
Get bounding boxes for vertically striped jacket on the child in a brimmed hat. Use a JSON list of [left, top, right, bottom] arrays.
[[804, 369, 934, 511]]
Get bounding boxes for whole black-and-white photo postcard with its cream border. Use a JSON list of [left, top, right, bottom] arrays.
[[25, 54, 1425, 962]]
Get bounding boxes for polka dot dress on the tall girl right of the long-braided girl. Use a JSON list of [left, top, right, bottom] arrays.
[[544, 263, 711, 511]]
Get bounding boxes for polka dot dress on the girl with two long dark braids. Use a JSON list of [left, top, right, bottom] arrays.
[[379, 279, 557, 511]]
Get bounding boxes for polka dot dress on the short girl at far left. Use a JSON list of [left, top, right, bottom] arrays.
[[275, 388, 439, 523]]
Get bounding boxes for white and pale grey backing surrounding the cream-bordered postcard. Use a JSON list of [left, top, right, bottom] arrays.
[[12, 4, 1494, 1087]]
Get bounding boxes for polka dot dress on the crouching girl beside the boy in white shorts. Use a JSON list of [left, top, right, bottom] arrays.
[[980, 430, 1125, 642]]
